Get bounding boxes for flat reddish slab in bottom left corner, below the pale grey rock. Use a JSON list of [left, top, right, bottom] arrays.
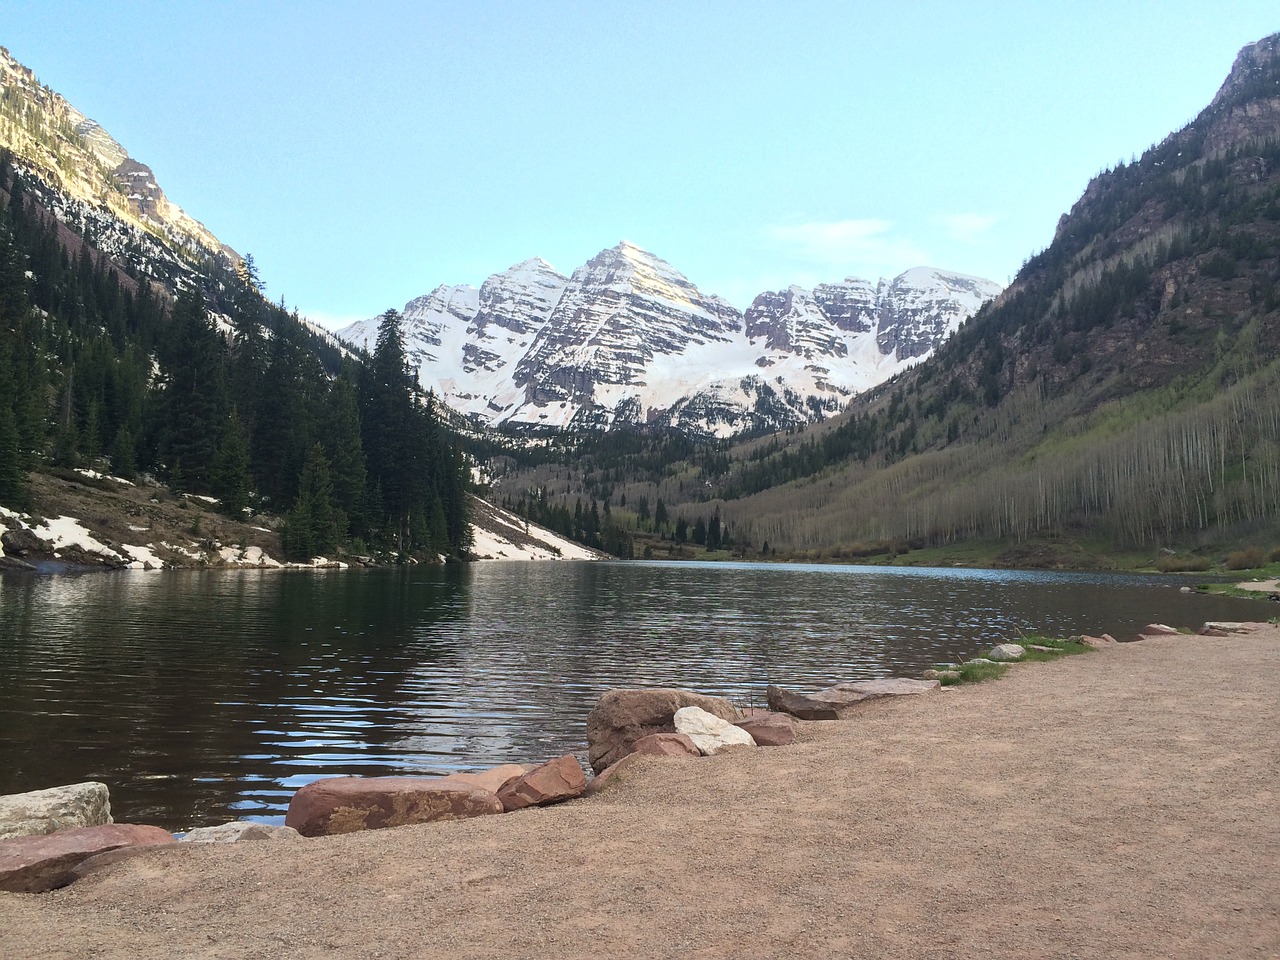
[[0, 823, 175, 893]]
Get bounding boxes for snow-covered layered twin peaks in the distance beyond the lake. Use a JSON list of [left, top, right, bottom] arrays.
[[338, 242, 1001, 436]]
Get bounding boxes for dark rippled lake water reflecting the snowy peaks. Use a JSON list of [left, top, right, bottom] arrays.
[[0, 563, 1272, 831]]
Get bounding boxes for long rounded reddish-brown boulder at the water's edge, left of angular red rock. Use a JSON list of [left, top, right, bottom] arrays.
[[284, 777, 503, 837]]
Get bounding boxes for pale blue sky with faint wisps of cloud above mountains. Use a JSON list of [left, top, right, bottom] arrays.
[[0, 0, 1280, 323]]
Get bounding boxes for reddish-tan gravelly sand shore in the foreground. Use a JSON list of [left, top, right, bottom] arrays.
[[0, 626, 1280, 960]]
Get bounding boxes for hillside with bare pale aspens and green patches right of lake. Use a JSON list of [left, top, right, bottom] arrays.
[[488, 37, 1280, 556]]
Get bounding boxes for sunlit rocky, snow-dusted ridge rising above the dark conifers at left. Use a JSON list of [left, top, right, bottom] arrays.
[[0, 47, 241, 284]]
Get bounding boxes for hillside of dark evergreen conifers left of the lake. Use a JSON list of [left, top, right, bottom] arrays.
[[0, 157, 468, 559]]
